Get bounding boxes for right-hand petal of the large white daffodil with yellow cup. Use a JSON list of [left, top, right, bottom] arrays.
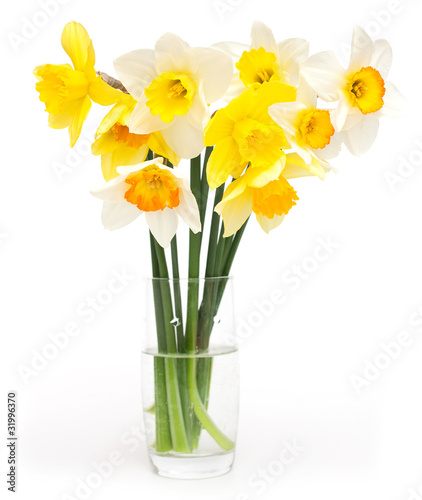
[[195, 48, 233, 104]]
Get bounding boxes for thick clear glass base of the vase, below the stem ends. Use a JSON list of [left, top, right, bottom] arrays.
[[149, 451, 234, 479]]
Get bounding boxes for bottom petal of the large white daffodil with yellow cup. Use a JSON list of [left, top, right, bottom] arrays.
[[162, 116, 205, 159]]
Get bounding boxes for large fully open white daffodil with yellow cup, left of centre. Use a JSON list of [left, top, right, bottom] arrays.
[[114, 33, 233, 158]]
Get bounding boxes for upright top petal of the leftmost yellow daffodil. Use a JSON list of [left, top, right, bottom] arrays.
[[62, 21, 95, 74]]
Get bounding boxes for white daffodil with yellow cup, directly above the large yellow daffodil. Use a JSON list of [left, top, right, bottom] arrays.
[[213, 21, 309, 101]]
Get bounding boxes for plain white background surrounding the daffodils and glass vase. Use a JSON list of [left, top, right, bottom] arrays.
[[0, 0, 422, 500]]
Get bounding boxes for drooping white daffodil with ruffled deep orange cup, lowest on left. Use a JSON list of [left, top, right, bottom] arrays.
[[91, 158, 201, 248]]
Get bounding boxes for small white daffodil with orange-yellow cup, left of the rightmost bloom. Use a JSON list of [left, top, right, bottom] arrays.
[[268, 83, 341, 179]]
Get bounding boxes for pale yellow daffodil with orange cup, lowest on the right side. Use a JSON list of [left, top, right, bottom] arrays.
[[215, 153, 310, 237]]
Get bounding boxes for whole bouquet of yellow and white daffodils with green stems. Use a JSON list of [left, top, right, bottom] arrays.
[[34, 22, 403, 453]]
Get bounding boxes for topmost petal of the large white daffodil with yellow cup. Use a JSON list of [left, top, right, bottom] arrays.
[[155, 33, 199, 75]]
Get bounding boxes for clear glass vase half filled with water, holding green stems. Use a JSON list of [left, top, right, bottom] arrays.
[[142, 277, 239, 479]]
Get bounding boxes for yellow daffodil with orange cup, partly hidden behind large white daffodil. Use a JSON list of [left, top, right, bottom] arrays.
[[91, 93, 180, 181]]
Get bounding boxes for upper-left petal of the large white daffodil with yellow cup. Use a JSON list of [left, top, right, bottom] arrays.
[[114, 49, 157, 100]]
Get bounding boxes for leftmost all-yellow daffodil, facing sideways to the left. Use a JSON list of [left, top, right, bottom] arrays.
[[34, 21, 121, 147]]
